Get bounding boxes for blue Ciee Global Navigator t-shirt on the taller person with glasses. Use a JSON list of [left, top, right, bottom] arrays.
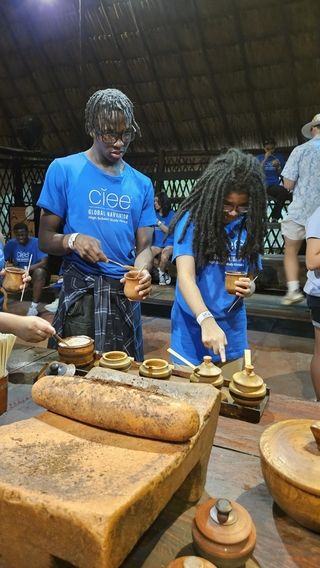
[[37, 152, 157, 279]]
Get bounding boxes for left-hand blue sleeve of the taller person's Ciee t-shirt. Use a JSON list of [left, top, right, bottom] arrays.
[[37, 160, 67, 223]]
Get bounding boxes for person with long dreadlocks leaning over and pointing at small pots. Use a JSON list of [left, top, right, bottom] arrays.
[[170, 149, 266, 367]]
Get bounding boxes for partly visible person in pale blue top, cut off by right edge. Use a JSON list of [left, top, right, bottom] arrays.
[[304, 207, 320, 402]]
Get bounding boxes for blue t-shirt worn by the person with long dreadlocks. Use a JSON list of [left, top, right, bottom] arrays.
[[171, 213, 258, 365]]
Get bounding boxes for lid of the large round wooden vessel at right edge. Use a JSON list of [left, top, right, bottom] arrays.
[[260, 419, 320, 495]]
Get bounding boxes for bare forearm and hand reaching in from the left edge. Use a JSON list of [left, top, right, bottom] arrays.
[[0, 312, 55, 343]]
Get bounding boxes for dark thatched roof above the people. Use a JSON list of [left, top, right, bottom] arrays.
[[0, 0, 320, 154]]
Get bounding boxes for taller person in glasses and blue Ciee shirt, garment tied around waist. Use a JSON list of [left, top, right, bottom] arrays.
[[38, 89, 157, 361]]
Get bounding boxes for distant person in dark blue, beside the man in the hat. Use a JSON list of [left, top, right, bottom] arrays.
[[257, 138, 292, 222]]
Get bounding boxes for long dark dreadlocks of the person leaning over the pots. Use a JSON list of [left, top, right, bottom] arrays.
[[170, 148, 267, 268]]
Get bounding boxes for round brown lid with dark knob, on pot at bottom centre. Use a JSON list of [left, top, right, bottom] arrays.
[[194, 498, 253, 545]]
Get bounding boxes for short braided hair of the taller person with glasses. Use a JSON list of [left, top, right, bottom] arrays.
[[85, 89, 140, 136]]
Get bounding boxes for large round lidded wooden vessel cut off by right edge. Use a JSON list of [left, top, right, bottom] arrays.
[[260, 420, 320, 533]]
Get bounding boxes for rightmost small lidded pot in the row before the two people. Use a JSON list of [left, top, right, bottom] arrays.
[[229, 364, 267, 407]]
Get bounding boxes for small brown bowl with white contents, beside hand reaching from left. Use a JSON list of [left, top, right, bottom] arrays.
[[58, 335, 94, 367]]
